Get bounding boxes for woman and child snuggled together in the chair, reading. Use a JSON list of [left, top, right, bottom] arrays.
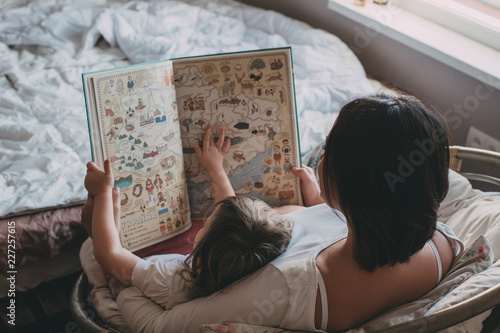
[[82, 94, 463, 332]]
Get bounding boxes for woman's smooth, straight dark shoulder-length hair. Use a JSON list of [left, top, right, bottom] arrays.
[[322, 94, 449, 271]]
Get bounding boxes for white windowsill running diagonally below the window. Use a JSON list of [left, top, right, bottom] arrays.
[[328, 0, 500, 90]]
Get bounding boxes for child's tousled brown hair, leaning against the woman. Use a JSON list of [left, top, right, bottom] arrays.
[[183, 196, 292, 296]]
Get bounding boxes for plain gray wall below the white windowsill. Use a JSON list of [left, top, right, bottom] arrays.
[[242, 0, 500, 187]]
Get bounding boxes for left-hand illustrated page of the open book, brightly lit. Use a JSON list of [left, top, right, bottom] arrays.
[[93, 61, 191, 251]]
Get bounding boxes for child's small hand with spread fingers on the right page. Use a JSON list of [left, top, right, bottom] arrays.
[[193, 125, 230, 173]]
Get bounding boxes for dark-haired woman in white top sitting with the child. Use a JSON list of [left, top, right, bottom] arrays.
[[91, 95, 463, 332]]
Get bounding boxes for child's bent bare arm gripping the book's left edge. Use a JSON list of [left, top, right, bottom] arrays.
[[85, 160, 140, 284]]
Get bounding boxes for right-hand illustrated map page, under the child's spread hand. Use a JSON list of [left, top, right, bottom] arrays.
[[174, 48, 302, 218]]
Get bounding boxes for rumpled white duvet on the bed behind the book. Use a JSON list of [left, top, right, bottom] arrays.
[[0, 0, 373, 216]]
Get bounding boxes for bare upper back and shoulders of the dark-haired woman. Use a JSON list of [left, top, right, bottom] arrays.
[[315, 224, 454, 331]]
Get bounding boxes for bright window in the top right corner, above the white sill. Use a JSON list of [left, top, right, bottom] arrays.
[[400, 0, 500, 50]]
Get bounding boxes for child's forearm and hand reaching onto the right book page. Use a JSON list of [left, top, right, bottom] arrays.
[[194, 125, 235, 202]]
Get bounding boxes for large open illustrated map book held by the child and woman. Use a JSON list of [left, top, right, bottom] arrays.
[[82, 48, 302, 251]]
